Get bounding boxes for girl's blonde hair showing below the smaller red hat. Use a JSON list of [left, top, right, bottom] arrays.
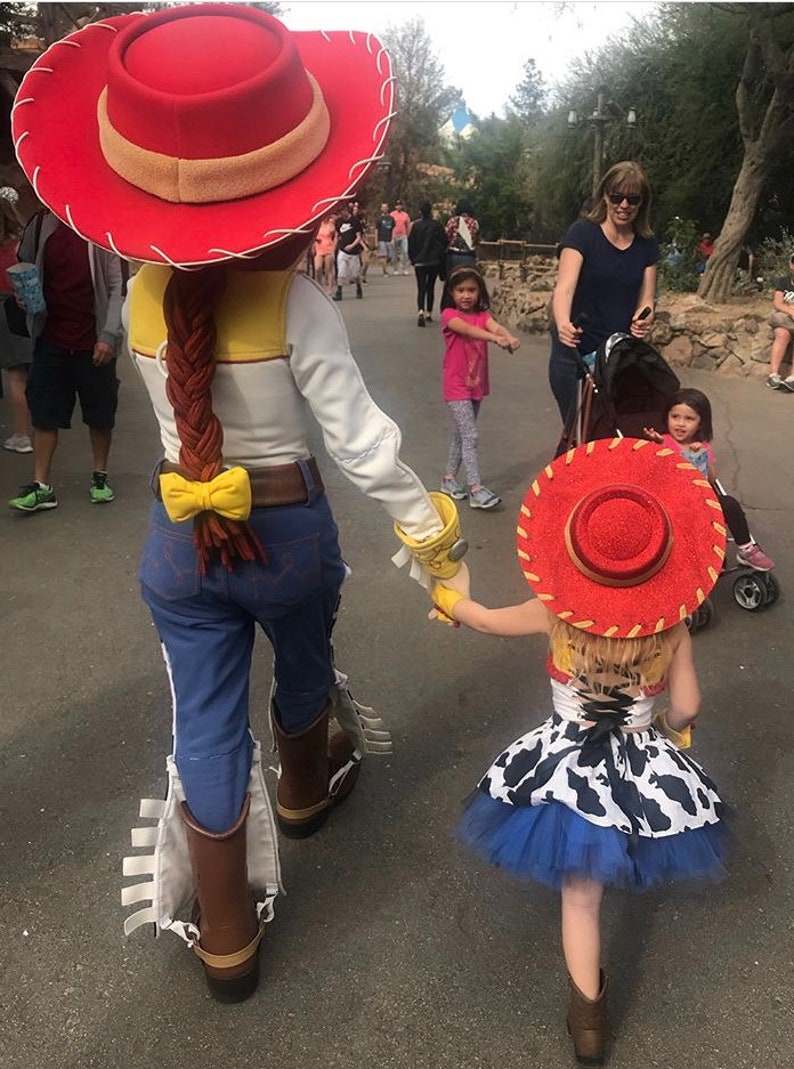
[[549, 617, 674, 694]]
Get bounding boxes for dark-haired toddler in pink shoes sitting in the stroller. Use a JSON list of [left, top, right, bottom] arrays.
[[644, 388, 775, 572]]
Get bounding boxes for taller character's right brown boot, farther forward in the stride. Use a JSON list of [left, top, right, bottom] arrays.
[[273, 706, 361, 839]]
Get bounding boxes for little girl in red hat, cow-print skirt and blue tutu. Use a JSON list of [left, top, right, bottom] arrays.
[[434, 438, 728, 1066]]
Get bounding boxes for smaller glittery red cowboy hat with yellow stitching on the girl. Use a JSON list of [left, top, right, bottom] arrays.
[[517, 438, 726, 638]]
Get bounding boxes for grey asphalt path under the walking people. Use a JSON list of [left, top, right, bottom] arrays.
[[0, 273, 794, 1069]]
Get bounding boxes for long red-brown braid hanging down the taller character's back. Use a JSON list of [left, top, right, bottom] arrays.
[[162, 265, 267, 574]]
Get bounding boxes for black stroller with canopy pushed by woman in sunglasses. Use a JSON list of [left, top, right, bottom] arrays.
[[555, 334, 780, 633]]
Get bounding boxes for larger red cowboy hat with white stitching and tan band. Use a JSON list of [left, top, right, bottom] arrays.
[[12, 3, 393, 266]]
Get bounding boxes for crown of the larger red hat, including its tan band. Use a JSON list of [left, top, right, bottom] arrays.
[[97, 5, 330, 203]]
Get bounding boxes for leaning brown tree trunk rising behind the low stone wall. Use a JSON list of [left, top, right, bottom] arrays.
[[698, 145, 765, 305]]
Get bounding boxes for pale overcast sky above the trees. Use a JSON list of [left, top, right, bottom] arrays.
[[281, 0, 657, 115]]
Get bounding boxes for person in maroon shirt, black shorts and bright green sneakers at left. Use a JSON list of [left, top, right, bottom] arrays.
[[9, 211, 124, 512]]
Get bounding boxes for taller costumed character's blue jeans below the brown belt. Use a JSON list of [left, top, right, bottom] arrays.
[[140, 496, 345, 832]]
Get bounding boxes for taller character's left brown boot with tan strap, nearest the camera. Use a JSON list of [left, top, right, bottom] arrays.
[[180, 794, 262, 1003]]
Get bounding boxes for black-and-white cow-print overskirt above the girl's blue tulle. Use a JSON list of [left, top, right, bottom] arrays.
[[480, 687, 723, 838]]
